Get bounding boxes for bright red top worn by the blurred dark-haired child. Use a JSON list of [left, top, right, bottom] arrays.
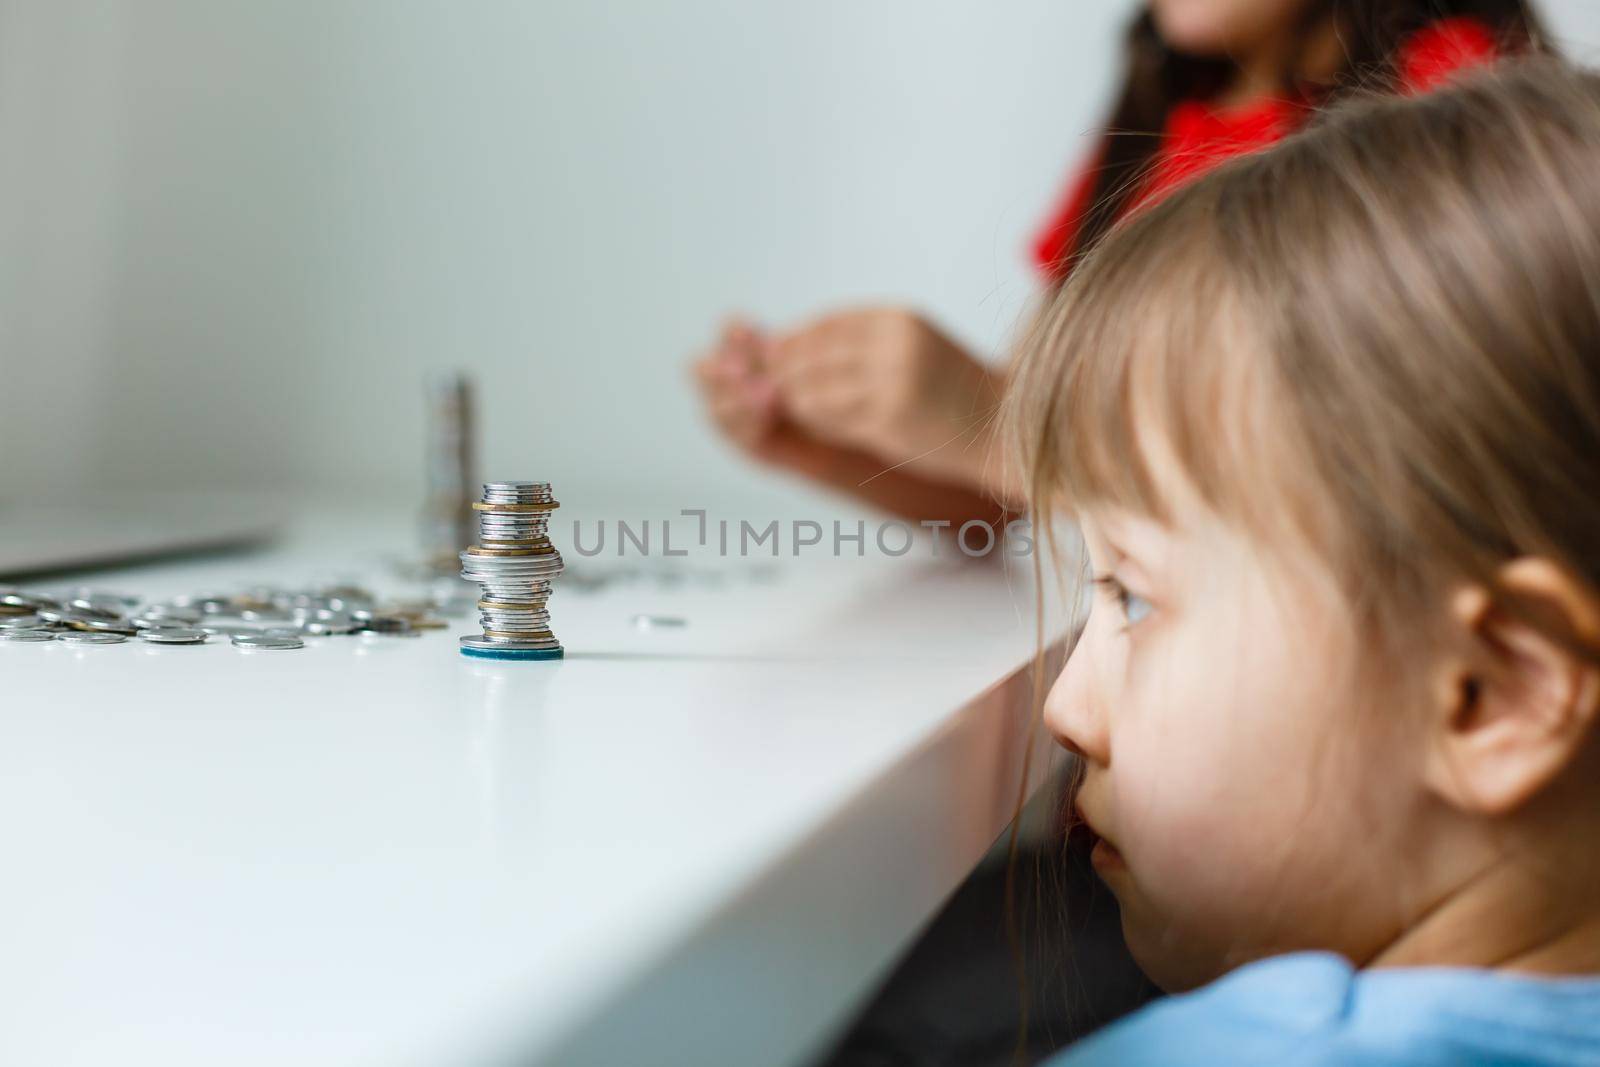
[[1032, 18, 1499, 283]]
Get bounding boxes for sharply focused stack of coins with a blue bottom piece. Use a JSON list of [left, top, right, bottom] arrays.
[[461, 482, 562, 659]]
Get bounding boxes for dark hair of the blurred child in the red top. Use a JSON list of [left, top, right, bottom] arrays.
[[1066, 0, 1547, 259]]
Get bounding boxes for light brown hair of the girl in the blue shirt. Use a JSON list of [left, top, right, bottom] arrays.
[[1006, 58, 1600, 668]]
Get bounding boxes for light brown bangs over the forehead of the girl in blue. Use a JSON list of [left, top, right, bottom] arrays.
[[1011, 181, 1285, 543]]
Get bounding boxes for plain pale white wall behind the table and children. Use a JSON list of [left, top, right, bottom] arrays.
[[0, 0, 1600, 502]]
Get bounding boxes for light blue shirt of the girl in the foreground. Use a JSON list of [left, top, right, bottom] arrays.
[[1048, 952, 1600, 1067]]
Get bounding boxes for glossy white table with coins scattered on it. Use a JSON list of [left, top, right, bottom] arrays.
[[0, 514, 1075, 1067]]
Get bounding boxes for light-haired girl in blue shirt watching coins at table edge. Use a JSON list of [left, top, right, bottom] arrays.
[[1008, 61, 1600, 1067]]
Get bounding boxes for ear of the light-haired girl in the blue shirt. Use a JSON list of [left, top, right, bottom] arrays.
[[1424, 557, 1600, 816]]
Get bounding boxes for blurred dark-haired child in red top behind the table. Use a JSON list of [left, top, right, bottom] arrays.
[[694, 0, 1541, 525]]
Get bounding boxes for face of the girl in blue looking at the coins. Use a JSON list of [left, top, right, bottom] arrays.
[[1045, 514, 1422, 990]]
